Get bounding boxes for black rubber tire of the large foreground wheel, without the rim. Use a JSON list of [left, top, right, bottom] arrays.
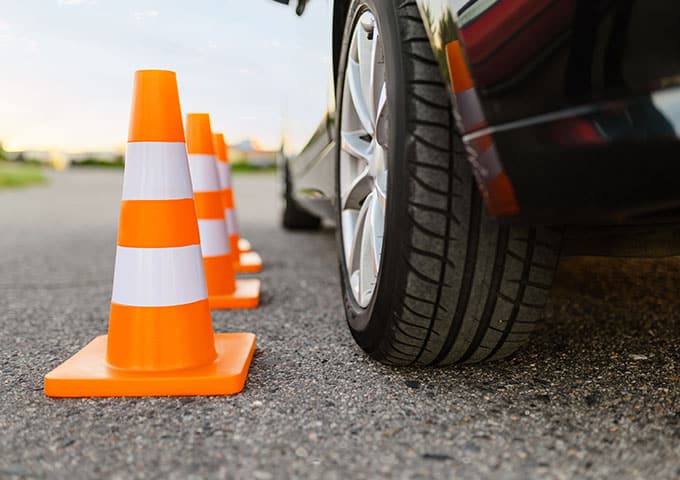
[[335, 0, 562, 365]]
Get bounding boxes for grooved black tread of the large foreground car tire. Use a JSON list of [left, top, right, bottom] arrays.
[[369, 0, 561, 365]]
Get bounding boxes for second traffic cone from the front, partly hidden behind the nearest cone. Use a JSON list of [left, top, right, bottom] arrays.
[[187, 113, 260, 309]]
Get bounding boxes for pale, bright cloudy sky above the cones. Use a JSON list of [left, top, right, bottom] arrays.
[[0, 0, 331, 152]]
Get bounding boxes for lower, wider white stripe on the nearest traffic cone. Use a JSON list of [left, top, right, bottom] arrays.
[[111, 245, 208, 307]]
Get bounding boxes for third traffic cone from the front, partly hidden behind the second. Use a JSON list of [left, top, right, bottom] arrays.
[[213, 133, 262, 273]]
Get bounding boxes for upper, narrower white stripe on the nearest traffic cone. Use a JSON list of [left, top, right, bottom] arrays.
[[123, 142, 193, 200]]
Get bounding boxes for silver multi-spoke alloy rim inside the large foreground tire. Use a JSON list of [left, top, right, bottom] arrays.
[[339, 10, 389, 308]]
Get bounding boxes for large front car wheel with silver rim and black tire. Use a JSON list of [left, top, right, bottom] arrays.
[[335, 0, 561, 365]]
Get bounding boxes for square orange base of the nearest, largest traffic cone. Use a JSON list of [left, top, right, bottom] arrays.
[[45, 333, 255, 397]]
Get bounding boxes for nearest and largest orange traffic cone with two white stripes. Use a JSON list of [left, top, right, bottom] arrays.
[[45, 70, 255, 397]]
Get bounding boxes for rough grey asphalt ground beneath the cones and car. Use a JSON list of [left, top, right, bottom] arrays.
[[0, 171, 680, 479]]
